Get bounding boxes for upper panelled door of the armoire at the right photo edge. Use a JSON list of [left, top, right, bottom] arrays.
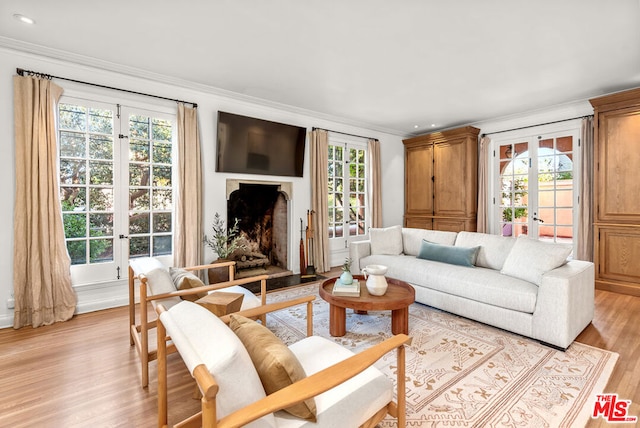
[[596, 108, 640, 224]]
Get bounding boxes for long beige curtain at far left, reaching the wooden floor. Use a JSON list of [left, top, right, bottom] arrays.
[[13, 76, 76, 329]]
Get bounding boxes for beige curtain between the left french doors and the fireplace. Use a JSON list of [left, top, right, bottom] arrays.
[[173, 103, 204, 266]]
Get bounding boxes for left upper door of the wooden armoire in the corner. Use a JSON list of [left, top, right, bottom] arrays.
[[405, 144, 433, 214]]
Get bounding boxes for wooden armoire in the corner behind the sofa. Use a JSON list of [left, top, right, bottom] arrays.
[[403, 126, 480, 232]]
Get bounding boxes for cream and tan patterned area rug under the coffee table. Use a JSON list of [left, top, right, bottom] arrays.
[[267, 285, 618, 427]]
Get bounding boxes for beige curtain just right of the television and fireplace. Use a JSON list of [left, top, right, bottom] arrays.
[[310, 129, 331, 272]]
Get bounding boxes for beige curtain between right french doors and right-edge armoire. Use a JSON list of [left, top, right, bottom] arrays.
[[577, 117, 593, 261]]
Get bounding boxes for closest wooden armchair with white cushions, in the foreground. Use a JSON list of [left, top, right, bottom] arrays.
[[156, 296, 411, 428]]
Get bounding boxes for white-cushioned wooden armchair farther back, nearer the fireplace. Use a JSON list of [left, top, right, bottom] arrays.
[[129, 257, 267, 388]]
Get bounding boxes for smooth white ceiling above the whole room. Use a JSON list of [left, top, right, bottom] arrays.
[[0, 0, 640, 135]]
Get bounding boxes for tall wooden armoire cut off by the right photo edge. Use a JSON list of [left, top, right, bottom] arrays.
[[589, 88, 640, 296]]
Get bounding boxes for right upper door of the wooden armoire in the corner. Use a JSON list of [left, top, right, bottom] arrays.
[[433, 138, 469, 216]]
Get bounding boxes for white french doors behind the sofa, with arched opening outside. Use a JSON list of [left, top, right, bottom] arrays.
[[492, 125, 579, 249]]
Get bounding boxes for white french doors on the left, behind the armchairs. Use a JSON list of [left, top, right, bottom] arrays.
[[58, 97, 175, 285]]
